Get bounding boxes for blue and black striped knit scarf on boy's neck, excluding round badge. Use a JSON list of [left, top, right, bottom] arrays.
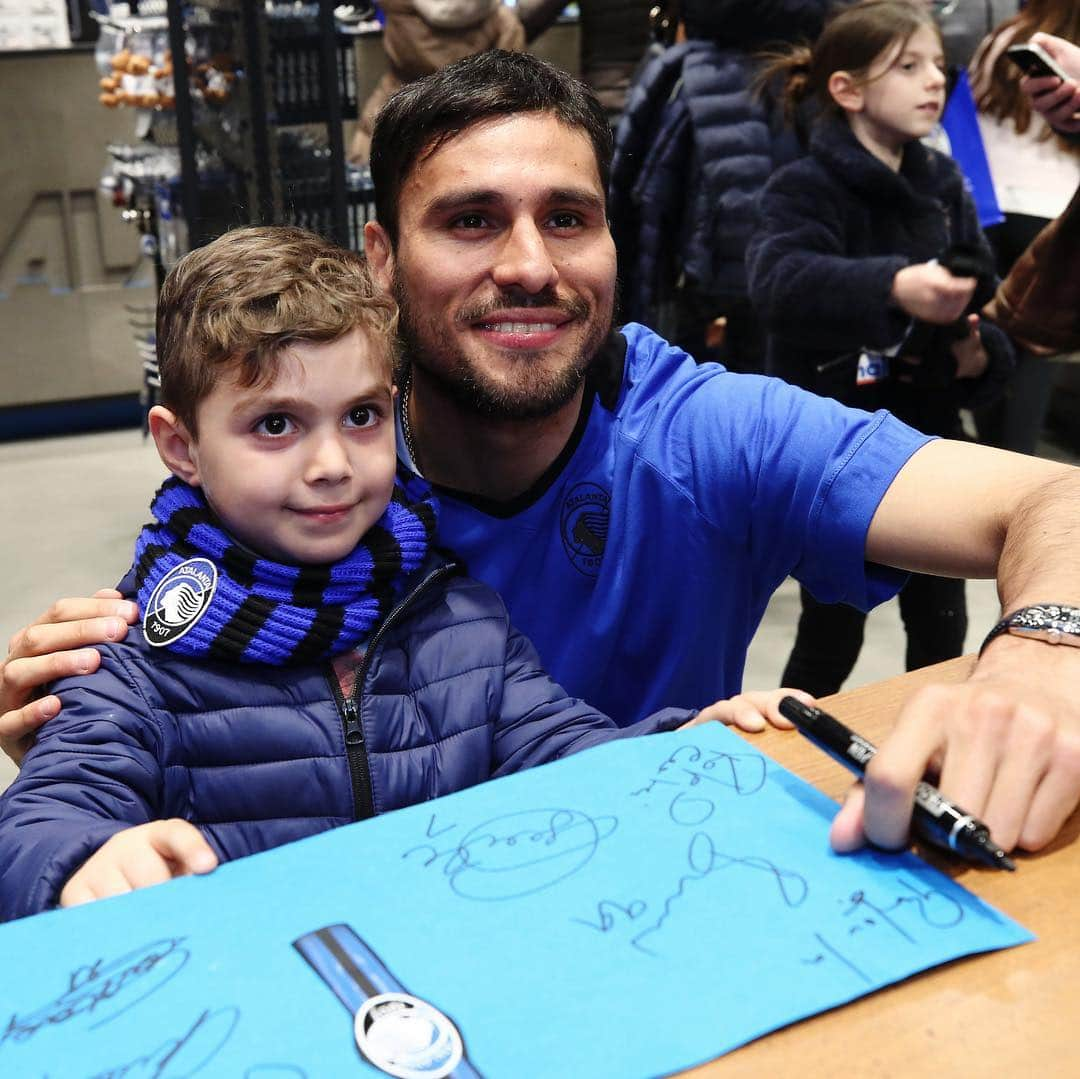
[[135, 473, 435, 665]]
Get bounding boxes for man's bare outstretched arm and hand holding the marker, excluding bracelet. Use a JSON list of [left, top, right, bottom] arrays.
[[859, 440, 1080, 850]]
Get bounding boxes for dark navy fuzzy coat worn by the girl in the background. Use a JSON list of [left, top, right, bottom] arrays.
[[746, 118, 1013, 434]]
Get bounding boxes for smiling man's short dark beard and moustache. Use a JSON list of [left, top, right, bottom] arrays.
[[393, 273, 613, 420]]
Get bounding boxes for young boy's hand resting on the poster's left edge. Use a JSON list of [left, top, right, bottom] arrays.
[[60, 819, 217, 906]]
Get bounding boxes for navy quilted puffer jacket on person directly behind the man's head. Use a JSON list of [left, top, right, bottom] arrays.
[[609, 0, 826, 326]]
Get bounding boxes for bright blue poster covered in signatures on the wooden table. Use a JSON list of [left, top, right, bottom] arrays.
[[0, 724, 1031, 1079]]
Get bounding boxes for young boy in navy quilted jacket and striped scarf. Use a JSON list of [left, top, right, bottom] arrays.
[[0, 228, 803, 918]]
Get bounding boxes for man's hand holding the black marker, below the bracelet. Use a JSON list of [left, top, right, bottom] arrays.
[[831, 636, 1080, 851]]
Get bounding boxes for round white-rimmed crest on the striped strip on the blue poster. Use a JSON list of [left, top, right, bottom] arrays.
[[354, 993, 464, 1079]]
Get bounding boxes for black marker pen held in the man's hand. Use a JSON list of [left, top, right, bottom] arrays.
[[780, 697, 1016, 869]]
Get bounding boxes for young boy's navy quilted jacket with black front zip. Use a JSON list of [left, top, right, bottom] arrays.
[[0, 564, 693, 919]]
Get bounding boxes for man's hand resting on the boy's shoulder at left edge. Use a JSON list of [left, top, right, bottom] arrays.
[[0, 589, 138, 764]]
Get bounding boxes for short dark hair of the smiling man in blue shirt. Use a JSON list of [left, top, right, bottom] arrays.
[[372, 50, 612, 244]]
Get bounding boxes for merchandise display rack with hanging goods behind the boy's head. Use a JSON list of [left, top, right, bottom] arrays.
[[95, 0, 374, 431]]
